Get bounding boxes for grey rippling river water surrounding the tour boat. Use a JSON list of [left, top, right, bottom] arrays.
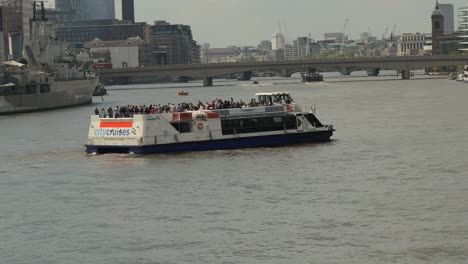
[[0, 72, 468, 264]]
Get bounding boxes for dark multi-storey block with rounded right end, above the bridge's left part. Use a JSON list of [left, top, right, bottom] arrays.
[[151, 21, 201, 64]]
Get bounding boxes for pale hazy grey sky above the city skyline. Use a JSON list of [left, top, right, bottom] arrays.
[[52, 0, 468, 47]]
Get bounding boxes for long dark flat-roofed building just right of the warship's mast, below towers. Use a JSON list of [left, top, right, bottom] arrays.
[[55, 20, 146, 48]]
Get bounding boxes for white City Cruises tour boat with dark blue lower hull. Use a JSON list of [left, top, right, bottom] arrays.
[[85, 92, 335, 154]]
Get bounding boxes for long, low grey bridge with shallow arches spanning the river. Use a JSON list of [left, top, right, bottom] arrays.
[[98, 55, 468, 86]]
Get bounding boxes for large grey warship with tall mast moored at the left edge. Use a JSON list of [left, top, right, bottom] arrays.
[[0, 1, 98, 114]]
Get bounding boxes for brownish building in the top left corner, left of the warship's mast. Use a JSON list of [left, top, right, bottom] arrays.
[[0, 0, 33, 60]]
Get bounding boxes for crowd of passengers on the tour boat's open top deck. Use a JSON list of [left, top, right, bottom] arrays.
[[94, 97, 273, 118]]
